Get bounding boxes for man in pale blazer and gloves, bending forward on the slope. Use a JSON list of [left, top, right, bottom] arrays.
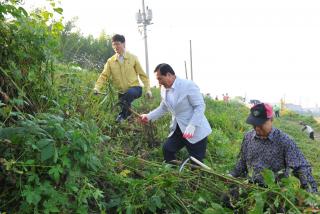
[[140, 63, 212, 163]]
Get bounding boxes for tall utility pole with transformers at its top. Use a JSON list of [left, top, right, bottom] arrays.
[[136, 0, 153, 77]]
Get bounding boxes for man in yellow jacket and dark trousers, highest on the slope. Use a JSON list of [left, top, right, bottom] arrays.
[[94, 34, 152, 122]]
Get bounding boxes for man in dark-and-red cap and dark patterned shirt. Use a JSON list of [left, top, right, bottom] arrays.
[[231, 103, 318, 192]]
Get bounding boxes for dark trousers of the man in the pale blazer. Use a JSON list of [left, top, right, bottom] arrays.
[[162, 125, 208, 162]]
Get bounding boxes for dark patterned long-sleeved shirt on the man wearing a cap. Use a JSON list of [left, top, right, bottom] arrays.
[[231, 128, 317, 192]]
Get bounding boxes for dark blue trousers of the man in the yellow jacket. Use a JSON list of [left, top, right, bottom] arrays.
[[119, 86, 142, 119]]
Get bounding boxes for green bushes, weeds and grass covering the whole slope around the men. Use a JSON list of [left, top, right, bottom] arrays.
[[0, 1, 320, 214]]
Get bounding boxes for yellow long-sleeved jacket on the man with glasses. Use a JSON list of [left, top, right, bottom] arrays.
[[94, 52, 150, 92]]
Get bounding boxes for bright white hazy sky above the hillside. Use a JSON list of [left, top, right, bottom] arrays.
[[25, 0, 320, 107]]
